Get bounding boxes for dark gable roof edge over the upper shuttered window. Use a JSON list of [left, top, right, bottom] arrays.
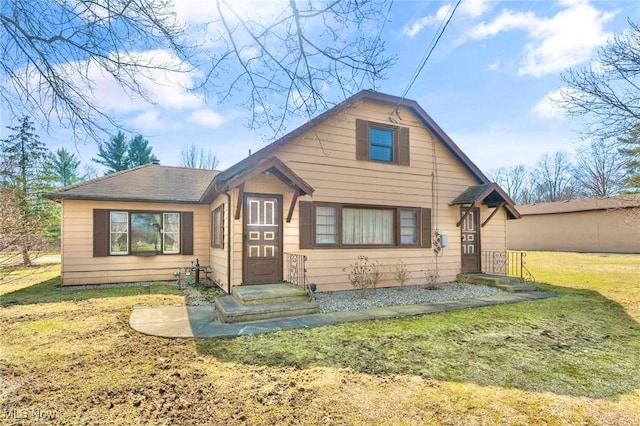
[[216, 90, 490, 184]]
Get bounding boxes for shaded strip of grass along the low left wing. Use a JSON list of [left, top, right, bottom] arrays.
[[0, 276, 181, 306]]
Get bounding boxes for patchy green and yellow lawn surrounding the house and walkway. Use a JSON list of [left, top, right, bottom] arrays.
[[0, 253, 640, 425]]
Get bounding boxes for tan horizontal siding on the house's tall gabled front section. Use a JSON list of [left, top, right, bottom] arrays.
[[222, 98, 492, 291]]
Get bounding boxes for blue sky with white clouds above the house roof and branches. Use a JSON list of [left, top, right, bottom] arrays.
[[2, 0, 640, 172]]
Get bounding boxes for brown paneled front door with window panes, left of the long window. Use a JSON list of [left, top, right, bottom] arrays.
[[243, 195, 282, 284]]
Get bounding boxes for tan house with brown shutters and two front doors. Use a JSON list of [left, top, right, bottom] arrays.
[[49, 90, 519, 291]]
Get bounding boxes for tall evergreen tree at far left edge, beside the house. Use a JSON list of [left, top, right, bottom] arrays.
[[0, 116, 57, 266]]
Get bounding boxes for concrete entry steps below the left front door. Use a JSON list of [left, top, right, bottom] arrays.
[[215, 283, 318, 323]]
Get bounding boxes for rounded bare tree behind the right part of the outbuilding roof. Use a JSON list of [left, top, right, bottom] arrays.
[[575, 141, 626, 197]]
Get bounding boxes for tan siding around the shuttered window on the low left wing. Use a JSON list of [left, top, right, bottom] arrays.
[[62, 200, 209, 285]]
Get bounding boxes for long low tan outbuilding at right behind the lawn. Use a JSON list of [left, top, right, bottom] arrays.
[[507, 194, 640, 253]]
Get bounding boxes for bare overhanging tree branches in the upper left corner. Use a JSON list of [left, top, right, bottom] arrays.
[[0, 0, 192, 136]]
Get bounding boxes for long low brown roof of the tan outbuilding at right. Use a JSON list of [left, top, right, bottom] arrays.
[[518, 194, 640, 216]]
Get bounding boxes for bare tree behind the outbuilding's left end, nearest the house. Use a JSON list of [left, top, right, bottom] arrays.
[[531, 151, 575, 202]]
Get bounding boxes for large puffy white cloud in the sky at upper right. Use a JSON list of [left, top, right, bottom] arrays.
[[468, 0, 618, 77]]
